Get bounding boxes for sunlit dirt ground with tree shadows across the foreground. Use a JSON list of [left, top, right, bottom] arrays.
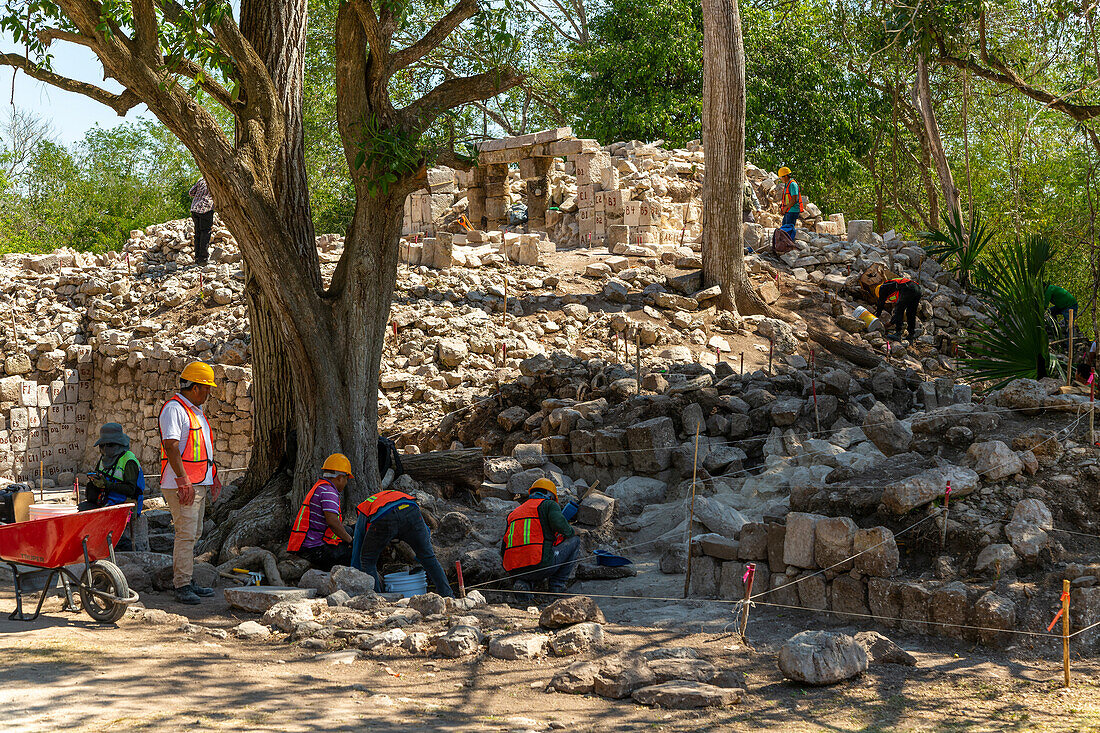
[[0, 572, 1100, 733]]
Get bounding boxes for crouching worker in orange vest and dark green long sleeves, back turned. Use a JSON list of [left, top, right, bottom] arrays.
[[501, 479, 581, 593]]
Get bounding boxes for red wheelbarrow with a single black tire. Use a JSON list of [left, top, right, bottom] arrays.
[[0, 504, 138, 623]]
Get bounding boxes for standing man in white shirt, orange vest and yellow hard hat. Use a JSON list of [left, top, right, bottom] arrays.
[[160, 361, 221, 605]]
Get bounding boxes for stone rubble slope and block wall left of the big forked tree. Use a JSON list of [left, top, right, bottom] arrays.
[[0, 220, 252, 488]]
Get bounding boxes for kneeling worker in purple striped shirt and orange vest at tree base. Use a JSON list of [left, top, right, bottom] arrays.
[[286, 453, 352, 571]]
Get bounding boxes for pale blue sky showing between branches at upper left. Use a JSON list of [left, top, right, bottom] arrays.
[[0, 34, 151, 144]]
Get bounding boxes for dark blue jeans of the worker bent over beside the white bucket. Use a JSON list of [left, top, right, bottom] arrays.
[[351, 501, 454, 598]]
